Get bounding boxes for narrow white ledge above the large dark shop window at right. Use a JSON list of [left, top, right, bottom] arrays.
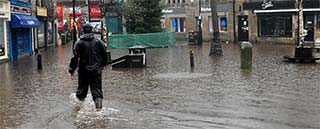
[[253, 8, 320, 13]]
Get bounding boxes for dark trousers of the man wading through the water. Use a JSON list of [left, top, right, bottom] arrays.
[[77, 73, 103, 101]]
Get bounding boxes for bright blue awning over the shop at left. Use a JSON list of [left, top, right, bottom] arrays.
[[11, 14, 40, 28]]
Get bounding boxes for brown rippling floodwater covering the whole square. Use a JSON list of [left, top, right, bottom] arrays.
[[0, 42, 320, 129]]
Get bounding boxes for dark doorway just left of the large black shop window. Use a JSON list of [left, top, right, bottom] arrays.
[[238, 16, 249, 41]]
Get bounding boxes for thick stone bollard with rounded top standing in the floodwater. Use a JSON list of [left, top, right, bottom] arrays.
[[241, 42, 252, 69]]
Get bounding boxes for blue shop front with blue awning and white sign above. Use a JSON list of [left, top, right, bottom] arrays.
[[9, 1, 40, 60]]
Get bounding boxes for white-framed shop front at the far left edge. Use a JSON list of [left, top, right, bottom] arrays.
[[0, 0, 10, 60]]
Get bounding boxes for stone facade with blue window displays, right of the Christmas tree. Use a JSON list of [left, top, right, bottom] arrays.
[[161, 0, 235, 41]]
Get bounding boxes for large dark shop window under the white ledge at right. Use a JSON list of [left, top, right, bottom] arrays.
[[258, 15, 292, 37]]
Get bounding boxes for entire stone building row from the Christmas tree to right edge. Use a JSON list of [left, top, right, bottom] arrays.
[[161, 0, 320, 43]]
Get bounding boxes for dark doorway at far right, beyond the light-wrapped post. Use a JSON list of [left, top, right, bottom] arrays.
[[303, 15, 314, 41]]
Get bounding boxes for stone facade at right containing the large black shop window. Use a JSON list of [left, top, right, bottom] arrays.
[[244, 0, 320, 44]]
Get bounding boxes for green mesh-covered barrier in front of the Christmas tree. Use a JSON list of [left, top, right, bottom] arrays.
[[108, 32, 176, 48]]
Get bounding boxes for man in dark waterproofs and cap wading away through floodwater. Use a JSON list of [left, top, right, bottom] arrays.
[[69, 23, 107, 110]]
